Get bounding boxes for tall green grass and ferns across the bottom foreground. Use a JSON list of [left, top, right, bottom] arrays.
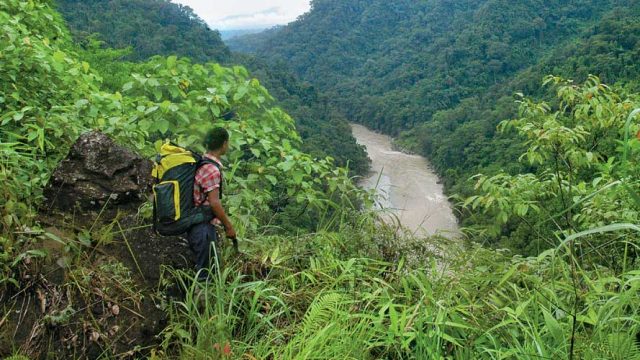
[[156, 217, 640, 359]]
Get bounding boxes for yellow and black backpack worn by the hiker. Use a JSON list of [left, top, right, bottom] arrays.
[[152, 144, 222, 236]]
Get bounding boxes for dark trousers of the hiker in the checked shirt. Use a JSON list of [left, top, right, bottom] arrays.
[[188, 223, 218, 280]]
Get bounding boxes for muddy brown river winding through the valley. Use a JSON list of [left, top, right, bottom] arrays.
[[351, 124, 458, 238]]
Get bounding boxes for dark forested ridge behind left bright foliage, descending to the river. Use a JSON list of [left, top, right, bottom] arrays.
[[56, 0, 369, 175]]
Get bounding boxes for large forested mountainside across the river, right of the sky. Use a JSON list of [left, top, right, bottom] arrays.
[[230, 0, 640, 254]]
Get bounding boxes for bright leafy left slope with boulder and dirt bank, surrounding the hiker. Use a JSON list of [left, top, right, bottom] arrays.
[[0, 0, 365, 359]]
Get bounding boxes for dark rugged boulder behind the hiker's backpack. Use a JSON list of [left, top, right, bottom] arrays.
[[45, 131, 152, 210]]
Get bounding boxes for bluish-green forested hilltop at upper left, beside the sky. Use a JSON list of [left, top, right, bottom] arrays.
[[56, 0, 231, 62]]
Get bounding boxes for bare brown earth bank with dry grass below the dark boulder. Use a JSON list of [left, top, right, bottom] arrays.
[[0, 207, 193, 359]]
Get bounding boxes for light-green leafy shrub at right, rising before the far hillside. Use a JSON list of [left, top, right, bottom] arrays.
[[464, 77, 640, 258]]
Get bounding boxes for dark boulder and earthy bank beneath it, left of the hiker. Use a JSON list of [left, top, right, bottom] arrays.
[[0, 132, 188, 359]]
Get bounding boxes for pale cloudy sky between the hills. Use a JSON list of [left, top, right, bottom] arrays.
[[173, 0, 309, 30]]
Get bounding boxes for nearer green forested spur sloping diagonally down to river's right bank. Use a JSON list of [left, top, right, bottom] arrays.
[[403, 5, 640, 187]]
